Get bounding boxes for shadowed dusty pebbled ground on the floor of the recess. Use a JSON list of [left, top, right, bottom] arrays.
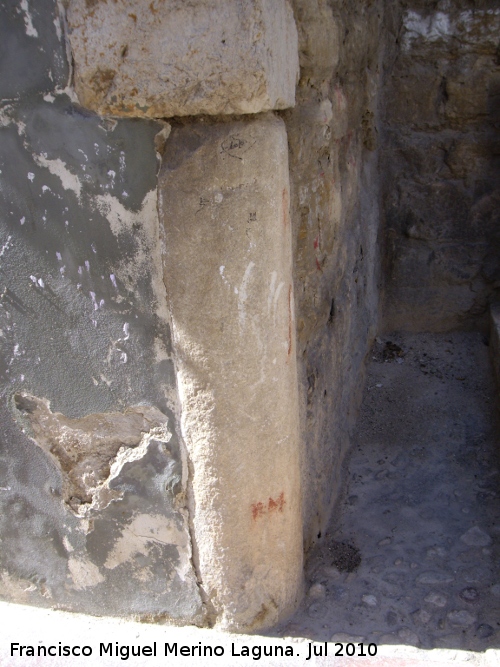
[[277, 333, 500, 651]]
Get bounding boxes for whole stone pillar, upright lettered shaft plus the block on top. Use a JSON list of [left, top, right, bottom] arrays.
[[68, 0, 302, 630]]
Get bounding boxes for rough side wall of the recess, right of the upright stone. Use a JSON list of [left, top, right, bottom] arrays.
[[283, 0, 383, 546]]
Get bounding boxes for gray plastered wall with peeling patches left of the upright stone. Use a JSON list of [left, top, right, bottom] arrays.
[[0, 0, 202, 621]]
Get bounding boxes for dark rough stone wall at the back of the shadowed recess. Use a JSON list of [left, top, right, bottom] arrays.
[[381, 0, 500, 331]]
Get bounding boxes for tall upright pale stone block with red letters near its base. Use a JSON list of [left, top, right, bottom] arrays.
[[159, 114, 302, 630]]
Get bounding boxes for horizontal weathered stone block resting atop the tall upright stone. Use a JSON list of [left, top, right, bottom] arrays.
[[68, 0, 299, 117]]
